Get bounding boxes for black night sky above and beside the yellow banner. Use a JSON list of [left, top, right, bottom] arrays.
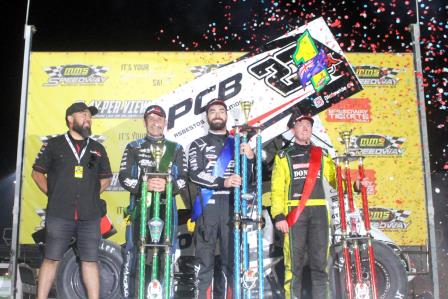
[[0, 0, 448, 290]]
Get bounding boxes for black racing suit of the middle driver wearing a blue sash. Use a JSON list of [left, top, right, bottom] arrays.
[[188, 132, 252, 299]]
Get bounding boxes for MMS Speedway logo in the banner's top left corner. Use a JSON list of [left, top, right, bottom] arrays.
[[44, 64, 108, 86]]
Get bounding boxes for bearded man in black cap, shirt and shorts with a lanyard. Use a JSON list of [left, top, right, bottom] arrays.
[[32, 102, 112, 299]]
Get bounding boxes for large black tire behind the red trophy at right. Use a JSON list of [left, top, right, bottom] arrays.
[[329, 240, 408, 299]]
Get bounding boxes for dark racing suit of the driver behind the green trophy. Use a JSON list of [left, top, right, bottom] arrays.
[[118, 136, 187, 298]]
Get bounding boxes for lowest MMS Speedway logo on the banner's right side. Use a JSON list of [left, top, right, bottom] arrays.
[[369, 207, 412, 231]]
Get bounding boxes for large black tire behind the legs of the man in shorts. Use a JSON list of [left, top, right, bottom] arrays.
[[56, 240, 123, 299]]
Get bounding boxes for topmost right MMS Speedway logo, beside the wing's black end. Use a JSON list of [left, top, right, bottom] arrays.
[[354, 65, 400, 87]]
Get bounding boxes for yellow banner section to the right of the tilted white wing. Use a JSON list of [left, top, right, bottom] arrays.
[[320, 54, 427, 246]]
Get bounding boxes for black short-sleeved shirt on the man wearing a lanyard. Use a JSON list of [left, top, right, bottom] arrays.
[[33, 133, 112, 220]]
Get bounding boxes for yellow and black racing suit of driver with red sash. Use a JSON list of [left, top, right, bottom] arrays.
[[271, 143, 336, 298]]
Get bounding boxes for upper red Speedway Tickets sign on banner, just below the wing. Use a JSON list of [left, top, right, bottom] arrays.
[[325, 98, 372, 123]]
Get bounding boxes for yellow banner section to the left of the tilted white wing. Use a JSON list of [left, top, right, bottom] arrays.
[[20, 52, 242, 244]]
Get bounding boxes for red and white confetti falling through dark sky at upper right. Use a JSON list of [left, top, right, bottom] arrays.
[[157, 0, 448, 171]]
